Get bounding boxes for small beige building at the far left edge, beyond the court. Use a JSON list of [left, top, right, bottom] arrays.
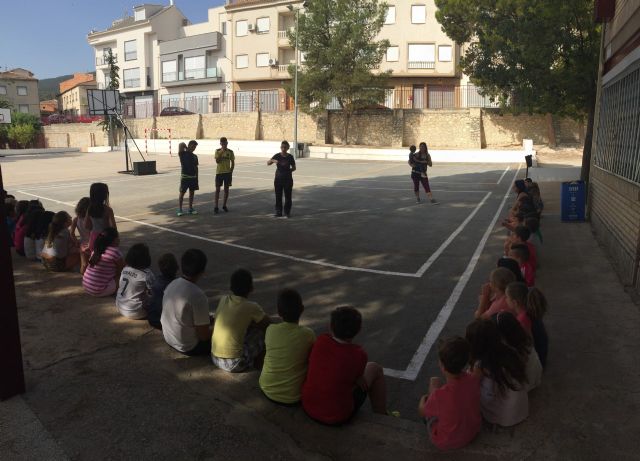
[[0, 68, 40, 116]]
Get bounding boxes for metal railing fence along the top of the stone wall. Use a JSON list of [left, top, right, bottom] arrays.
[[123, 85, 499, 118]]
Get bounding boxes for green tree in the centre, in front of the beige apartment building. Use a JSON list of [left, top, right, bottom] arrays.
[[287, 0, 390, 144]]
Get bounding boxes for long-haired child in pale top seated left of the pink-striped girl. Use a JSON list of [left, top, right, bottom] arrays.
[[42, 211, 80, 272]]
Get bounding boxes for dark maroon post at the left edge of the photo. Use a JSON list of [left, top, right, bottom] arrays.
[[0, 166, 25, 400]]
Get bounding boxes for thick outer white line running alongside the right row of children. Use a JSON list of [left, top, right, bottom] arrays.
[[384, 165, 520, 381]]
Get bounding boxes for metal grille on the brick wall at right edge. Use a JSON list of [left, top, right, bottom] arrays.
[[594, 64, 640, 184]]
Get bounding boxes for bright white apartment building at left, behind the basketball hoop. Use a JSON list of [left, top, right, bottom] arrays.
[[87, 2, 189, 117]]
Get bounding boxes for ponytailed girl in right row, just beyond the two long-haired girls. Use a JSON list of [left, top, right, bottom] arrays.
[[507, 283, 549, 368]]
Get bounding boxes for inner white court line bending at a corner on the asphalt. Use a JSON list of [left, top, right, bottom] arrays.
[[17, 183, 491, 278]]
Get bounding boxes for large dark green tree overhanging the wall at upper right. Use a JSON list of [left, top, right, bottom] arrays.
[[436, 0, 600, 179]]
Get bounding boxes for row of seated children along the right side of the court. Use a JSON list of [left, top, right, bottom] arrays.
[[419, 180, 548, 450]]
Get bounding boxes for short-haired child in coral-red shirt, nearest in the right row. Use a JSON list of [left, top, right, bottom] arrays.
[[418, 337, 482, 450]]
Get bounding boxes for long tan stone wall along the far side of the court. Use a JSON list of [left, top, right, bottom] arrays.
[[44, 109, 584, 150]]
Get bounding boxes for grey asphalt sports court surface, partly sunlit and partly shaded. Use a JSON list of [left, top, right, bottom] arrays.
[[5, 153, 524, 417]]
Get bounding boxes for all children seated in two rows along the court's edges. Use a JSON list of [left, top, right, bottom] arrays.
[[5, 180, 548, 450]]
